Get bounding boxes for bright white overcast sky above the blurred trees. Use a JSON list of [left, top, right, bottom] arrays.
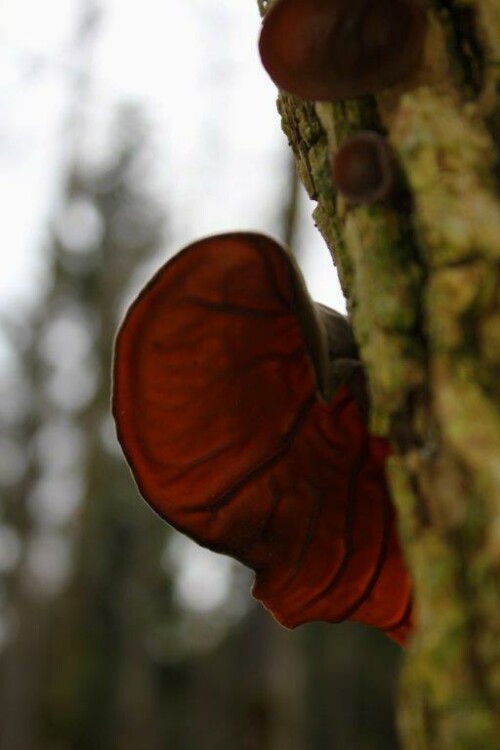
[[0, 0, 345, 608]]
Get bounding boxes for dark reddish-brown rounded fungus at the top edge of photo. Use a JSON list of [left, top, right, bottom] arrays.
[[259, 0, 426, 100]]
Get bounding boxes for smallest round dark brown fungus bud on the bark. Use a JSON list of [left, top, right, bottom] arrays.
[[332, 130, 397, 203]]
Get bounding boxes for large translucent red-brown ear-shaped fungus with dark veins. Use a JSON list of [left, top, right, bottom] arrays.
[[113, 234, 411, 643]]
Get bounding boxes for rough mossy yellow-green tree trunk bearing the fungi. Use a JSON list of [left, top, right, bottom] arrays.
[[259, 0, 500, 750]]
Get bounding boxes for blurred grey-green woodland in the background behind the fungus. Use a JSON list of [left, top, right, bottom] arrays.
[[0, 3, 399, 750]]
